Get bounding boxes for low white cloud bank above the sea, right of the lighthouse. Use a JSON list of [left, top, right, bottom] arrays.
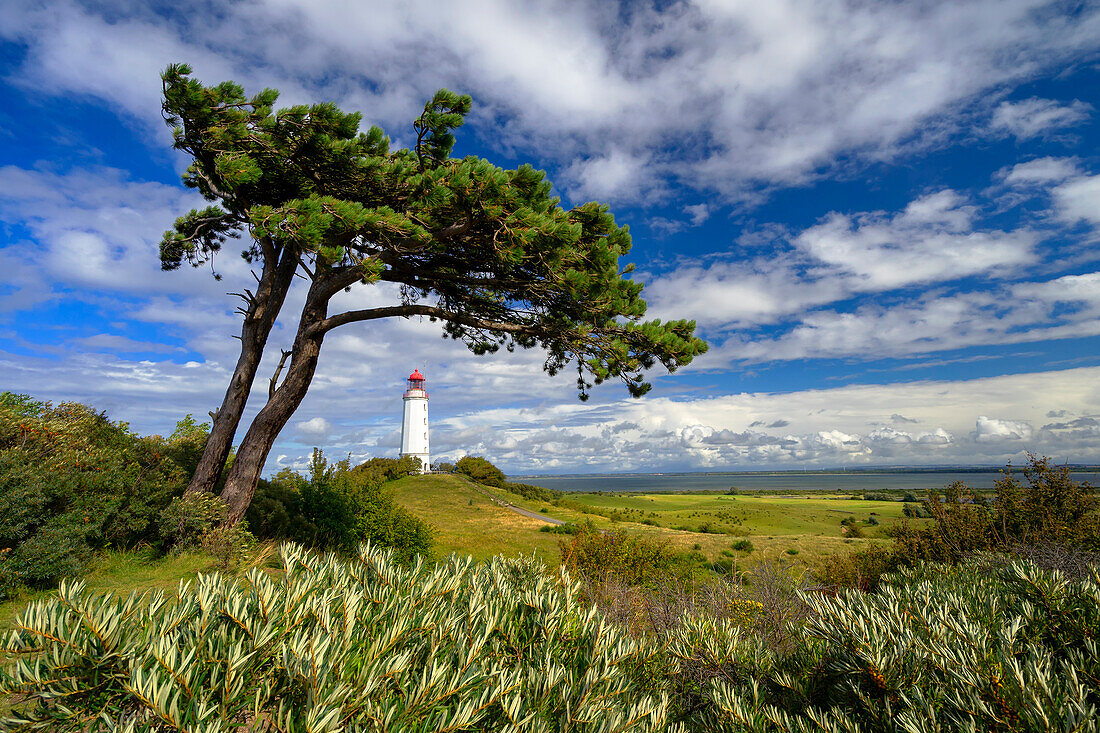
[[432, 368, 1100, 472]]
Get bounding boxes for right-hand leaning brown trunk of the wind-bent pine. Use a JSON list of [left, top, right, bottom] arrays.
[[221, 283, 330, 525]]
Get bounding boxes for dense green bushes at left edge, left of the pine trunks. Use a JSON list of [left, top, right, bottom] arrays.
[[0, 392, 191, 597]]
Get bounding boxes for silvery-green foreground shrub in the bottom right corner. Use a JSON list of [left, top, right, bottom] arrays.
[[669, 564, 1100, 731]]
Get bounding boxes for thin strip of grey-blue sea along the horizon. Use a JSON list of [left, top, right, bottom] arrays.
[[508, 469, 1100, 492]]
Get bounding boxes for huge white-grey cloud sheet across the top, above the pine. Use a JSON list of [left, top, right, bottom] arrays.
[[0, 0, 1100, 198]]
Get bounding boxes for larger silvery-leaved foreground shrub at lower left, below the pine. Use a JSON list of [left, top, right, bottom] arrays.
[[0, 545, 668, 733]]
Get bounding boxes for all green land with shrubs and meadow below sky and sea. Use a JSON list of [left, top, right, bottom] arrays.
[[0, 393, 1100, 733]]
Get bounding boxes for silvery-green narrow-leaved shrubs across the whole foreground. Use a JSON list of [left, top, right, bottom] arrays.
[[0, 546, 1100, 733]]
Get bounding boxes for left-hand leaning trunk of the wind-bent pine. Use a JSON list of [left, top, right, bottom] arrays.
[[186, 251, 298, 494]]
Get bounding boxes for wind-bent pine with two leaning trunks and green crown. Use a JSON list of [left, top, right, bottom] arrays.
[[161, 65, 706, 522]]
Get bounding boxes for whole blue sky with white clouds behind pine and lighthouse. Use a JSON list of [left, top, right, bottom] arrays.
[[0, 0, 1100, 474]]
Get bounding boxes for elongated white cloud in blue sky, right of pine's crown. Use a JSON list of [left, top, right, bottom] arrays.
[[640, 182, 1041, 334]]
